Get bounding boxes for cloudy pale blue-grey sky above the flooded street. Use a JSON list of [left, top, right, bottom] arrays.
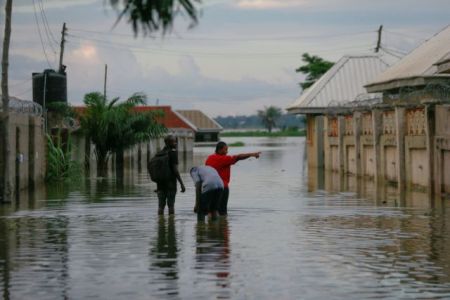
[[0, 0, 450, 117]]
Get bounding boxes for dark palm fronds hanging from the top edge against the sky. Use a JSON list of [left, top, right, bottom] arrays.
[[109, 0, 200, 34]]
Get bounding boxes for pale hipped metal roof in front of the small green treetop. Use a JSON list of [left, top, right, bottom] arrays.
[[287, 55, 388, 110]]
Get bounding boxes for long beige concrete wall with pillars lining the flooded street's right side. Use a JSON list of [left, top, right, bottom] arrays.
[[307, 103, 450, 196]]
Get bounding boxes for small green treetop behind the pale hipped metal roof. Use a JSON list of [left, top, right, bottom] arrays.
[[295, 53, 334, 90]]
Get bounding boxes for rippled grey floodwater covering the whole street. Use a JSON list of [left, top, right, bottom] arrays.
[[0, 138, 450, 299]]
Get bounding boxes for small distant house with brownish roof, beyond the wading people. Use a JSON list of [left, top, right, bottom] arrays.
[[176, 110, 223, 142]]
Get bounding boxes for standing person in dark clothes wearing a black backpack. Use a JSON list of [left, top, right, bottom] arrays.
[[148, 135, 186, 215]]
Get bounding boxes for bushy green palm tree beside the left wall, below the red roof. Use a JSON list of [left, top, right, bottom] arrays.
[[80, 92, 166, 177]]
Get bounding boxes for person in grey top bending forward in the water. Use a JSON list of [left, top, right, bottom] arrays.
[[190, 166, 223, 222]]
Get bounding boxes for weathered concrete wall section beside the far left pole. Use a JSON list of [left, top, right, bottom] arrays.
[[0, 112, 46, 199]]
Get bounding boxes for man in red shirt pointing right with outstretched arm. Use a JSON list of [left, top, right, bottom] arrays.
[[205, 142, 261, 216]]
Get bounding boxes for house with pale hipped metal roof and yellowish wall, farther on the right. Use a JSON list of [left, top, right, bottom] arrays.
[[287, 54, 389, 169]]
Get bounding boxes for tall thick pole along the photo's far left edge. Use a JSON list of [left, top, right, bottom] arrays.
[[0, 0, 12, 202]]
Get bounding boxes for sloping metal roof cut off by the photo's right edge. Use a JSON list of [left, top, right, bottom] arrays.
[[367, 26, 450, 87]]
